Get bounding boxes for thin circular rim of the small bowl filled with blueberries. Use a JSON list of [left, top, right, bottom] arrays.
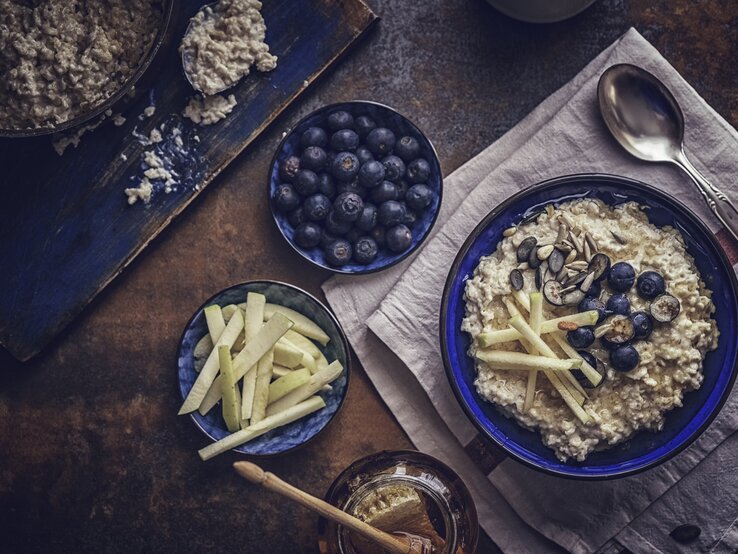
[[267, 100, 443, 275]]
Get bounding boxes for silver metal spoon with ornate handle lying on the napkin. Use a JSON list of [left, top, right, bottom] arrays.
[[597, 64, 738, 240]]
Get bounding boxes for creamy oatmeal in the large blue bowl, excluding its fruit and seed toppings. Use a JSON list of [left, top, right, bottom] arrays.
[[462, 200, 719, 461]]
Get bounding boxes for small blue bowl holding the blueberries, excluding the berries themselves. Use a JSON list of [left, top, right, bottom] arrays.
[[268, 100, 443, 275]]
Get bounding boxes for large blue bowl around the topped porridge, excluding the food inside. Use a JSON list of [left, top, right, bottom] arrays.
[[440, 175, 738, 479]]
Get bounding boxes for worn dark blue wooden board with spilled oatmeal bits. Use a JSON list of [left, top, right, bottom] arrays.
[[0, 0, 377, 360]]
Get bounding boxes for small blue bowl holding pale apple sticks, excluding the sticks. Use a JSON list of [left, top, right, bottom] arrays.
[[177, 281, 350, 457]]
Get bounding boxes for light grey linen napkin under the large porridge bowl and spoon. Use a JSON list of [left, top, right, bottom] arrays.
[[324, 30, 738, 552]]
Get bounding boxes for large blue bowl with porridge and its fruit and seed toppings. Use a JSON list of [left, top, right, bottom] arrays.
[[440, 175, 738, 479]]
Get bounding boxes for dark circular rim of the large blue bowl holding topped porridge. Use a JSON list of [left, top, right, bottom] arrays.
[[439, 173, 738, 481]]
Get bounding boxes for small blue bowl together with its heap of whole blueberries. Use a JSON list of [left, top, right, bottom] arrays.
[[269, 101, 443, 274]]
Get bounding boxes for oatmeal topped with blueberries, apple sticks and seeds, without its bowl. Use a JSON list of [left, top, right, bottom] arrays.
[[462, 199, 719, 461]]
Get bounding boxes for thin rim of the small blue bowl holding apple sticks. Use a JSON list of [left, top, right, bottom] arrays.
[[177, 279, 351, 459]]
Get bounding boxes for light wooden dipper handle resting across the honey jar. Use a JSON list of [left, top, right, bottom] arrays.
[[233, 462, 432, 554]]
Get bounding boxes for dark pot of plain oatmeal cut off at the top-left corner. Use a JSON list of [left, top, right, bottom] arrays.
[[0, 0, 174, 137]]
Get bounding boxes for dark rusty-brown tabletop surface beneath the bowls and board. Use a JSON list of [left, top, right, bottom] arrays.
[[0, 0, 738, 553]]
